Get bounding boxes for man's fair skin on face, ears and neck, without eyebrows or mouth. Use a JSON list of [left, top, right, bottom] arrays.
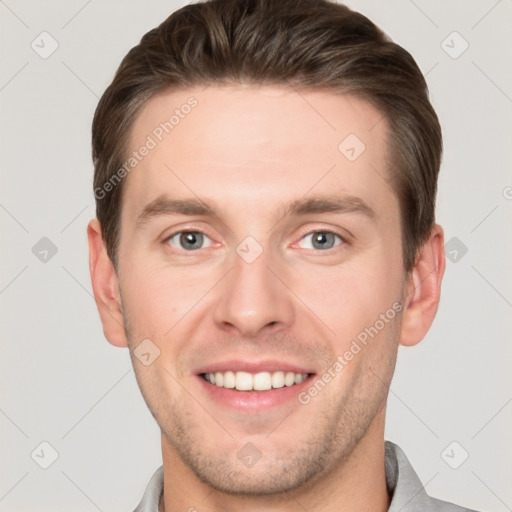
[[88, 85, 445, 512]]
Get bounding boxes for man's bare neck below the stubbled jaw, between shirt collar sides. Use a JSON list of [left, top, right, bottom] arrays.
[[159, 411, 390, 512]]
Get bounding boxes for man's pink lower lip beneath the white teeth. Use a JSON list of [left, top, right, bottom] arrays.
[[197, 375, 314, 412]]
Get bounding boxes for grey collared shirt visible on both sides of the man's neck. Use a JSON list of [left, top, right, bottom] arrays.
[[134, 441, 475, 512]]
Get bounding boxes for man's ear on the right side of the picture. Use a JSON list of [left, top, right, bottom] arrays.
[[400, 224, 446, 346]]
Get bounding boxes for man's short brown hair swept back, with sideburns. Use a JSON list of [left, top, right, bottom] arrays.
[[92, 0, 442, 271]]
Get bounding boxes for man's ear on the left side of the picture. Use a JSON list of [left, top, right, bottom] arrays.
[[87, 219, 128, 347]]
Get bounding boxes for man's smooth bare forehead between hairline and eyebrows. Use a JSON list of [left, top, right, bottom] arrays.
[[123, 85, 394, 221]]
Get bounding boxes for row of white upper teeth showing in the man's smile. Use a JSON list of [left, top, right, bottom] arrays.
[[204, 371, 308, 391]]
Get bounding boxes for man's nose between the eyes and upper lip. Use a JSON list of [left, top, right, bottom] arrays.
[[214, 245, 295, 337]]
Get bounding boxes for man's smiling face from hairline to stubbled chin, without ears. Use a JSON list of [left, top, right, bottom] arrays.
[[118, 86, 405, 494]]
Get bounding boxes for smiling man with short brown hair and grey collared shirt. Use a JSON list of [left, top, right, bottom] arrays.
[[88, 0, 480, 512]]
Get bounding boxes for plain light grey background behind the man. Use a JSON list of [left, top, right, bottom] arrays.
[[0, 0, 512, 512]]
